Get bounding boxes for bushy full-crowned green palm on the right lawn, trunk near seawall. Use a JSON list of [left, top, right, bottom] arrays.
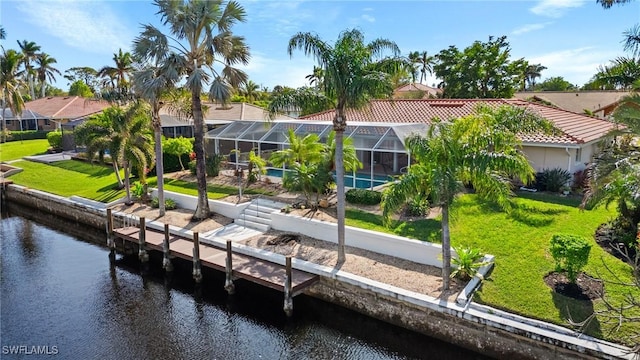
[[382, 106, 552, 290]]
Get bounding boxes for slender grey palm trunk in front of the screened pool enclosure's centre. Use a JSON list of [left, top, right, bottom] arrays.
[[333, 110, 346, 264]]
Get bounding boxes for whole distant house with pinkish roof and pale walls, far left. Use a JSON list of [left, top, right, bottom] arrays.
[[0, 96, 109, 131]]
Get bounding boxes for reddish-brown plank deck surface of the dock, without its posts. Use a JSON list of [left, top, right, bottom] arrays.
[[114, 227, 319, 296]]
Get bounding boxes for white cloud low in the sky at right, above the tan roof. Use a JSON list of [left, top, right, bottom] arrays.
[[527, 47, 617, 86]]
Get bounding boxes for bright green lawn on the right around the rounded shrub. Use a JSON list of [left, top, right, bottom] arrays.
[[347, 193, 640, 341]]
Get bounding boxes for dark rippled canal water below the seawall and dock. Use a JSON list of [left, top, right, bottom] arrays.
[[0, 205, 484, 360]]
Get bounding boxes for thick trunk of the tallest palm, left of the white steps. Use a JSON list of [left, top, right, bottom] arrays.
[[191, 90, 210, 220]]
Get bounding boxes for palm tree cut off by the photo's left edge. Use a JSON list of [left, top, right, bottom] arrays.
[[0, 48, 24, 140]]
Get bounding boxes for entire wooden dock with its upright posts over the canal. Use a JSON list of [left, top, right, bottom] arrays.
[[107, 209, 319, 315]]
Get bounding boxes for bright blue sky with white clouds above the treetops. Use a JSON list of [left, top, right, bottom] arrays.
[[0, 0, 640, 90]]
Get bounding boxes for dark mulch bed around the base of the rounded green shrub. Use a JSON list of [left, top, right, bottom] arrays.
[[544, 272, 604, 301]]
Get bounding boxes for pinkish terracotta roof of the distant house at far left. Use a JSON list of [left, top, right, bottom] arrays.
[[24, 96, 109, 120]]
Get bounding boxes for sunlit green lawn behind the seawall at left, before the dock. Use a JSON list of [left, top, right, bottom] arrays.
[[10, 160, 125, 202]]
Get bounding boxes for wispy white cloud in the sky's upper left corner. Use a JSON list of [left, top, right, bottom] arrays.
[[17, 0, 133, 54]]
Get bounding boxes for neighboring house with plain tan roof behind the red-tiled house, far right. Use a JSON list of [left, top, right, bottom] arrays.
[[514, 90, 629, 119]]
